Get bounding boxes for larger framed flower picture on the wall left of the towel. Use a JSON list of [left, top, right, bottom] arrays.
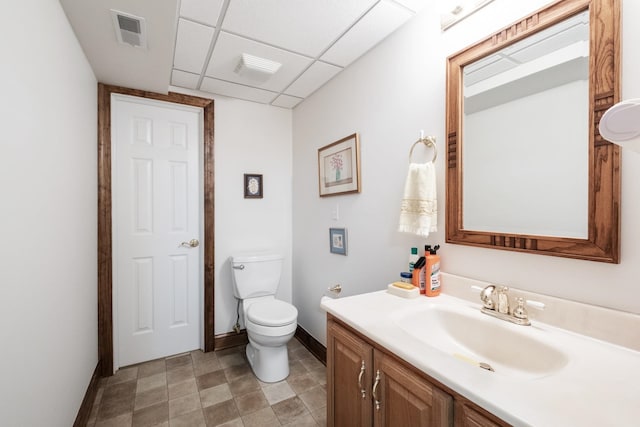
[[318, 133, 360, 197]]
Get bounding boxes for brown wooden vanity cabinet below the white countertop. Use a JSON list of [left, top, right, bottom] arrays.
[[327, 315, 508, 427]]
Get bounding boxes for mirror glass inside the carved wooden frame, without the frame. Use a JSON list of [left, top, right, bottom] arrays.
[[462, 11, 589, 239]]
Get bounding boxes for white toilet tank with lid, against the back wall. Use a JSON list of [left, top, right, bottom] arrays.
[[231, 253, 282, 299]]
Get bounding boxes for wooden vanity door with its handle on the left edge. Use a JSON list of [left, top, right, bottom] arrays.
[[372, 350, 453, 427]]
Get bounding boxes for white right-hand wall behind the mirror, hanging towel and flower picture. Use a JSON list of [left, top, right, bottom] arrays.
[[293, 0, 640, 341]]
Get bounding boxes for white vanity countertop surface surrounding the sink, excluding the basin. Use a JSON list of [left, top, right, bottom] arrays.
[[321, 291, 640, 427]]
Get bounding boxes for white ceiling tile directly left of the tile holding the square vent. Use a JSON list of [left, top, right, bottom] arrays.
[[173, 18, 214, 74]]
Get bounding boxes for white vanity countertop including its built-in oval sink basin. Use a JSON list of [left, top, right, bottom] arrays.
[[321, 288, 640, 426]]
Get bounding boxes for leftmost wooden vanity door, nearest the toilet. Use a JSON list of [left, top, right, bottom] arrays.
[[327, 320, 373, 427]]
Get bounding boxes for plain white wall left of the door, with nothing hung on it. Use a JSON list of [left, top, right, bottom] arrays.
[[0, 0, 98, 427]]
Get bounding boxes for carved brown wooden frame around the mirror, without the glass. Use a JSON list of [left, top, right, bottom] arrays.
[[446, 0, 620, 263]]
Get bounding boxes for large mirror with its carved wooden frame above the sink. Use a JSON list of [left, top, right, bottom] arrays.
[[446, 0, 620, 263]]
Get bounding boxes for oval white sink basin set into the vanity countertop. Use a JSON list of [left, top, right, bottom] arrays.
[[393, 304, 568, 378]]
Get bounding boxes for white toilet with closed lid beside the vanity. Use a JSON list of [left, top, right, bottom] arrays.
[[231, 254, 298, 383]]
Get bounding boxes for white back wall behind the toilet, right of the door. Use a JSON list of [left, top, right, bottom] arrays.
[[215, 97, 291, 334]]
